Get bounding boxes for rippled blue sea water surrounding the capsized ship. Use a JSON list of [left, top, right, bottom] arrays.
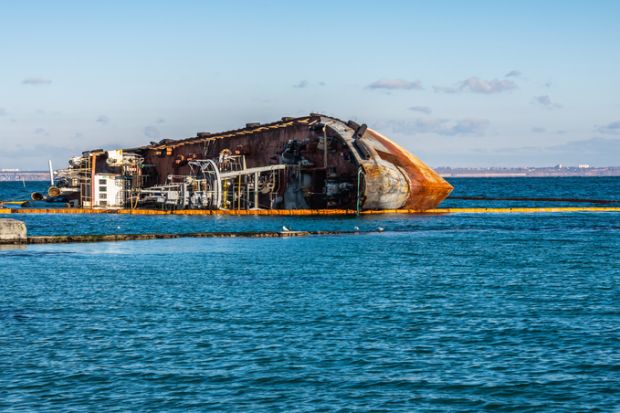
[[0, 178, 620, 412]]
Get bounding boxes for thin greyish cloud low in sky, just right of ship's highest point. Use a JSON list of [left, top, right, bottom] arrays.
[[390, 118, 489, 136]]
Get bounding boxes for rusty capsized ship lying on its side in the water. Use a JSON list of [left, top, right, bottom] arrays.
[[42, 113, 453, 211]]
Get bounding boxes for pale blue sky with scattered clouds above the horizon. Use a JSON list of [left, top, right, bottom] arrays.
[[0, 0, 620, 169]]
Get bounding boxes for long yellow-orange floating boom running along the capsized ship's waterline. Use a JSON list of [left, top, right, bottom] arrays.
[[0, 207, 620, 216]]
